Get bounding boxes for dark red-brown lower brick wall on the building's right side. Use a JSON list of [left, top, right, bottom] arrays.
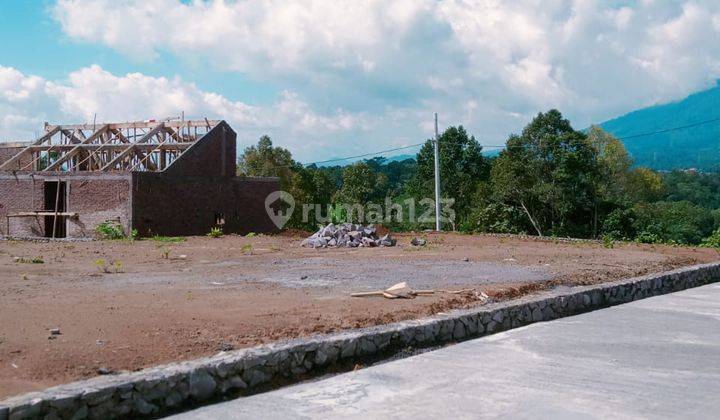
[[132, 172, 280, 236]]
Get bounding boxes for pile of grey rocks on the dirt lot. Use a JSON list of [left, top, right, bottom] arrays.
[[300, 223, 396, 248]]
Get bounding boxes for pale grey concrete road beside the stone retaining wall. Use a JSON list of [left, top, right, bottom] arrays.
[[172, 284, 720, 420]]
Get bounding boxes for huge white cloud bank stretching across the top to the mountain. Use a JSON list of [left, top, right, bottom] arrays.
[[53, 0, 720, 125]]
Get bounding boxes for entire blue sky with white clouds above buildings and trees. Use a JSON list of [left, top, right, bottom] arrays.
[[0, 0, 720, 162]]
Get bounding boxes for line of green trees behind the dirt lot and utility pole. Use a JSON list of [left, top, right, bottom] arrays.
[[238, 110, 720, 246]]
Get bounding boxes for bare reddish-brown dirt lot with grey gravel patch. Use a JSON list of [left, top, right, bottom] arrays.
[[0, 234, 720, 397]]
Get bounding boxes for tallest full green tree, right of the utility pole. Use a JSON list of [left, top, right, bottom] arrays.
[[491, 110, 600, 237]]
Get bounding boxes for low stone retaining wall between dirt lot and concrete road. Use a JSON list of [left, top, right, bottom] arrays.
[[0, 263, 720, 420]]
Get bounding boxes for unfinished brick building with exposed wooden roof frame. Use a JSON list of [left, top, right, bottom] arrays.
[[0, 119, 280, 238]]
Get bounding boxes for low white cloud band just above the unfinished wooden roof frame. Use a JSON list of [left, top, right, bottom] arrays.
[[0, 65, 382, 162]]
